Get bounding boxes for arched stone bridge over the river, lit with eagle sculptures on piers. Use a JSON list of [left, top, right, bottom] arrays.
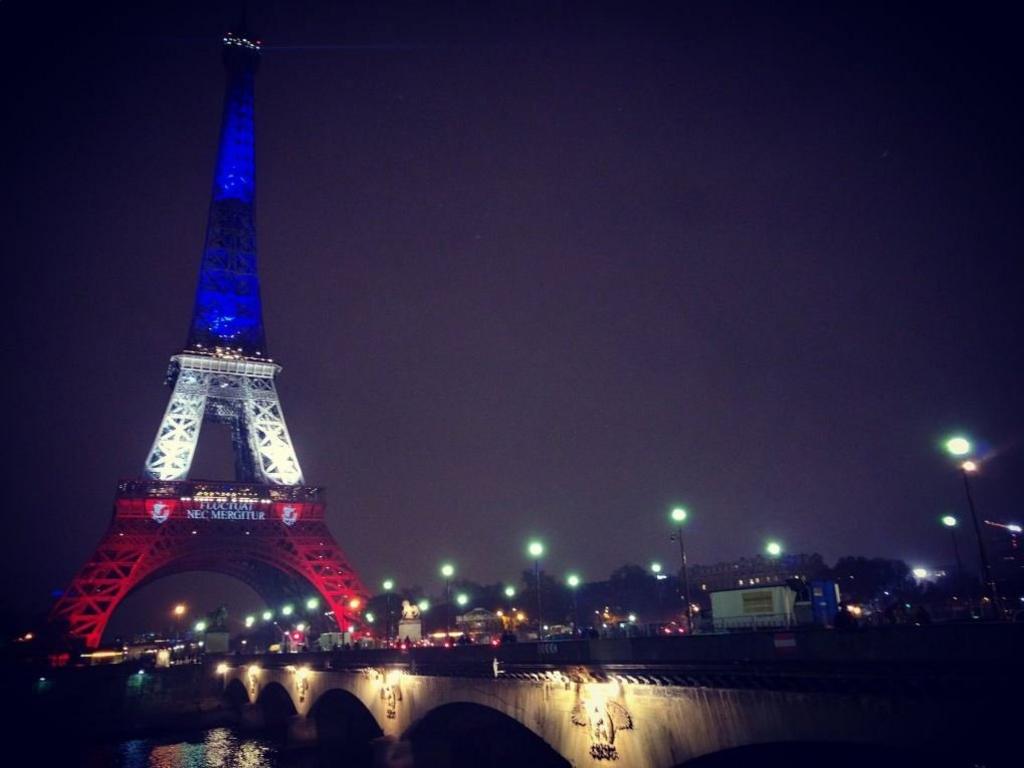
[[211, 625, 1024, 768]]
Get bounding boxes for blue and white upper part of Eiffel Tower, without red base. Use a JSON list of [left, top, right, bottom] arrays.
[[144, 35, 302, 485]]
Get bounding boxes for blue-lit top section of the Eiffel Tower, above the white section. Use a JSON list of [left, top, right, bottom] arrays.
[[187, 35, 266, 357]]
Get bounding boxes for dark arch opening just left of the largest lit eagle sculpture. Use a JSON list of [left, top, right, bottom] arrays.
[[403, 701, 570, 768]]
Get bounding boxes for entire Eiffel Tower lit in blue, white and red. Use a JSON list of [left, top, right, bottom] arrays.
[[50, 28, 366, 647]]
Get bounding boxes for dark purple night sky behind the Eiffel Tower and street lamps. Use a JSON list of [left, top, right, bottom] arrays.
[[0, 0, 1024, 628]]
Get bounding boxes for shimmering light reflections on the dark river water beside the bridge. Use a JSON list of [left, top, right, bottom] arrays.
[[111, 728, 282, 768]]
